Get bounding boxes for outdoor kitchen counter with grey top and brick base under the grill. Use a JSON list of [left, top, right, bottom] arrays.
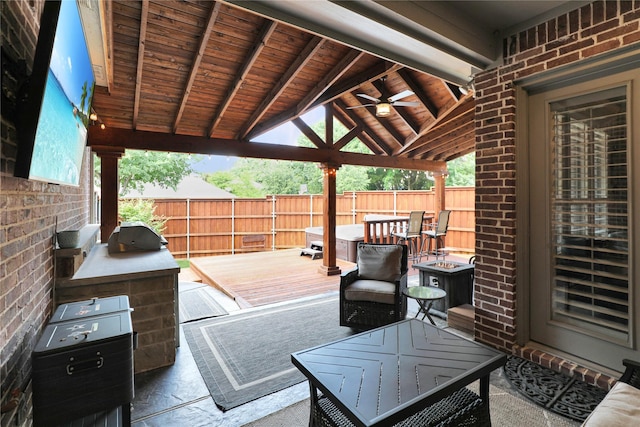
[[55, 244, 180, 373]]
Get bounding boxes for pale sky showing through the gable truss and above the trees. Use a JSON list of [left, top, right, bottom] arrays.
[[193, 107, 324, 173]]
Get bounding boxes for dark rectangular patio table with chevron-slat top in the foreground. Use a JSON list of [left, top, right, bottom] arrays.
[[291, 319, 506, 427]]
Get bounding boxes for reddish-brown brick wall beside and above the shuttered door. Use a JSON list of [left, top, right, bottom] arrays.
[[475, 0, 640, 382]]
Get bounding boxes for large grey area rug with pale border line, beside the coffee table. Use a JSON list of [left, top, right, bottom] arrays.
[[184, 295, 352, 411]]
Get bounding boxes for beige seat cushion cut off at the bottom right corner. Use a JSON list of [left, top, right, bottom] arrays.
[[582, 381, 640, 427]]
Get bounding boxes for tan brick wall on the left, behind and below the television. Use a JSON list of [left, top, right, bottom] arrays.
[[0, 0, 92, 426]]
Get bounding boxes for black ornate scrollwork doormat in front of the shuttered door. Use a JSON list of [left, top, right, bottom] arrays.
[[503, 356, 607, 422]]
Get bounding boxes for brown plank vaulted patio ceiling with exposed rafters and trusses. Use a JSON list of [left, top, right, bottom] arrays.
[[89, 0, 475, 170]]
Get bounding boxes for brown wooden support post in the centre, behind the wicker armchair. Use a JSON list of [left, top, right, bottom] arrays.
[[318, 163, 341, 276]]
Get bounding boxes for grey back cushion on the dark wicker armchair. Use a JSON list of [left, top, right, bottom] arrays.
[[357, 245, 402, 282]]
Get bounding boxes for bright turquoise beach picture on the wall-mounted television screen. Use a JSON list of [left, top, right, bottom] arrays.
[[29, 1, 95, 185]]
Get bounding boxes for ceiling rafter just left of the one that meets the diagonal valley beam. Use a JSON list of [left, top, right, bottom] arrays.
[[236, 36, 325, 139]]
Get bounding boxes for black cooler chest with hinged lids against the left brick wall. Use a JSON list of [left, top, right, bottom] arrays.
[[32, 300, 134, 426]]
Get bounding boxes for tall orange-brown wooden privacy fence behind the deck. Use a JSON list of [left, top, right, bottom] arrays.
[[145, 187, 475, 259]]
